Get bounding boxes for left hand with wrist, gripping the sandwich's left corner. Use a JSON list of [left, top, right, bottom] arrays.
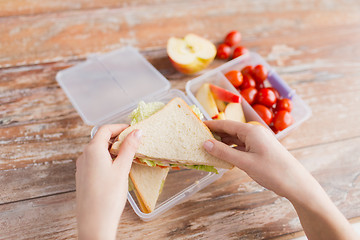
[[76, 124, 141, 239]]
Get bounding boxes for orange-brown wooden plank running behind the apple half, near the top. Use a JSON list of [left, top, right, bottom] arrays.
[[0, 0, 360, 67]]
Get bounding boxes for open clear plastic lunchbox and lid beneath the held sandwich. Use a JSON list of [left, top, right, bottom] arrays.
[[56, 47, 226, 221]]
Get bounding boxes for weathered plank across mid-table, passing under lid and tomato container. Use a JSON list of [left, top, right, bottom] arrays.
[[0, 57, 360, 169]]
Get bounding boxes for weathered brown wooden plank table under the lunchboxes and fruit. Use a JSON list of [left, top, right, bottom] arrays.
[[0, 0, 360, 239]]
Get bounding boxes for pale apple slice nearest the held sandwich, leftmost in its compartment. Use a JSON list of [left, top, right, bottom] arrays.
[[195, 83, 219, 117]]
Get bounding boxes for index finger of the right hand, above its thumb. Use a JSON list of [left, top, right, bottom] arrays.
[[204, 120, 251, 142]]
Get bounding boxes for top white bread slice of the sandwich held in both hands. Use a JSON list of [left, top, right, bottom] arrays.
[[110, 98, 233, 169]]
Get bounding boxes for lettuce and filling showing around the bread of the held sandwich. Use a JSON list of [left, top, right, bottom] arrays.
[[130, 101, 218, 173]]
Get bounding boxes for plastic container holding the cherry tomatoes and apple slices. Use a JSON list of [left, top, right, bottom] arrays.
[[186, 52, 311, 139]]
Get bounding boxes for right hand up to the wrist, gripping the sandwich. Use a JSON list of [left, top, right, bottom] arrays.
[[204, 120, 317, 202]]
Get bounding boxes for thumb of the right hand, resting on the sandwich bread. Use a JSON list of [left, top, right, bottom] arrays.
[[204, 139, 251, 170]]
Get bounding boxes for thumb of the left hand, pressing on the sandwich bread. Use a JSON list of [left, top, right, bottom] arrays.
[[113, 129, 141, 174]]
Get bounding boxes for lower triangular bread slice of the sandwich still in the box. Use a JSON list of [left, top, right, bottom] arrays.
[[129, 163, 169, 213]]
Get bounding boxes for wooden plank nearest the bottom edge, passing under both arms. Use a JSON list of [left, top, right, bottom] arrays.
[[0, 138, 360, 239]]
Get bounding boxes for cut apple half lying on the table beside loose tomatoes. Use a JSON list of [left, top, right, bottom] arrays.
[[166, 33, 216, 74]]
